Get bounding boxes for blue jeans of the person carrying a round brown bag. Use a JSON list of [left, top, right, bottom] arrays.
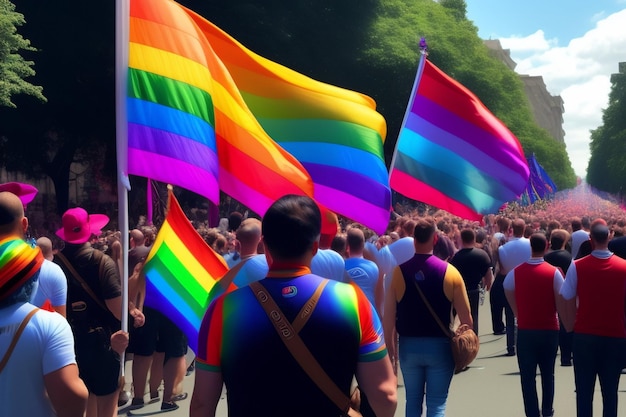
[[398, 336, 454, 417]]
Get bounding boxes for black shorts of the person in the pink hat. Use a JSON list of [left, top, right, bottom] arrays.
[[74, 327, 120, 396]]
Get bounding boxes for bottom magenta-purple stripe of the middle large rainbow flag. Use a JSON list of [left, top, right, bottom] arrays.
[[315, 184, 391, 235]]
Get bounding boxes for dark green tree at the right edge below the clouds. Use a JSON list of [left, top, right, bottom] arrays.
[[587, 69, 626, 195]]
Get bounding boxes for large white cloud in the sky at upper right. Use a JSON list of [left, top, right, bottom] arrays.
[[492, 9, 626, 177]]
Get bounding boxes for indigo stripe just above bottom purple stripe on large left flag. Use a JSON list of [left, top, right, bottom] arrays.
[[128, 123, 218, 175]]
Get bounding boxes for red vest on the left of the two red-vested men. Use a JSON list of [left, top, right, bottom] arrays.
[[515, 262, 559, 330]]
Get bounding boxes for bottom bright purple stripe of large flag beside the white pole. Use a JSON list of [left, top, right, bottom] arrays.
[[128, 148, 220, 204]]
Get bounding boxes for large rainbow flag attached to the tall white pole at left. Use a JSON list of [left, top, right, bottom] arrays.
[[127, 0, 313, 215]]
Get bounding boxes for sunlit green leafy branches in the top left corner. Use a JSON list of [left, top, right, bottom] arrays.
[[0, 0, 46, 107]]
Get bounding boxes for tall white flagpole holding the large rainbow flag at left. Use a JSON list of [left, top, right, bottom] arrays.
[[115, 0, 130, 334]]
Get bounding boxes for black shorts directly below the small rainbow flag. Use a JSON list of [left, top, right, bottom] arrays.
[[128, 307, 188, 360]]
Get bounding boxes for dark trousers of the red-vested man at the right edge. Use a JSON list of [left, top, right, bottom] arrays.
[[573, 333, 626, 417]]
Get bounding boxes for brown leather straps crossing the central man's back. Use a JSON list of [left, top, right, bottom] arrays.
[[250, 280, 350, 413]]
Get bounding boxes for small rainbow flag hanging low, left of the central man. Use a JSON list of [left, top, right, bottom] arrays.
[[143, 191, 228, 352]]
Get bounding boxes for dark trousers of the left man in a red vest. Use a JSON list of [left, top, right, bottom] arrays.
[[517, 329, 559, 417]]
